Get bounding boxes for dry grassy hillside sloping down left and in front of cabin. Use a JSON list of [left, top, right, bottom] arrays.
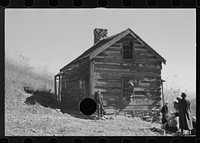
[[5, 56, 173, 136]]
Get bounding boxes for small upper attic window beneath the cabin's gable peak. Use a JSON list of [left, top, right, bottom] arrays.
[[122, 41, 134, 59]]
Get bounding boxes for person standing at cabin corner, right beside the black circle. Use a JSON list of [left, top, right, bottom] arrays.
[[95, 90, 103, 119]]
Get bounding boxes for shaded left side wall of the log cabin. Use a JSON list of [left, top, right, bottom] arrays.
[[61, 59, 89, 110]]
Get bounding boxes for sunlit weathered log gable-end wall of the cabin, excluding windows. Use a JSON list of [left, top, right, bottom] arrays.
[[93, 35, 162, 111]]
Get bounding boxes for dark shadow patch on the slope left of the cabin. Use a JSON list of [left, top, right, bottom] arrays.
[[24, 87, 60, 109]]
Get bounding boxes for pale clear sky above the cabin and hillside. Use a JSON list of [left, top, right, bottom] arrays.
[[5, 8, 196, 98]]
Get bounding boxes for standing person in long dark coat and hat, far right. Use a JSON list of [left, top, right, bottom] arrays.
[[178, 93, 193, 134]]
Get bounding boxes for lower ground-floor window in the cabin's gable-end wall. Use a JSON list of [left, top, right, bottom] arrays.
[[122, 78, 133, 97]]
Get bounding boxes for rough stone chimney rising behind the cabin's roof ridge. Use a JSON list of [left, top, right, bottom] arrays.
[[94, 28, 108, 44]]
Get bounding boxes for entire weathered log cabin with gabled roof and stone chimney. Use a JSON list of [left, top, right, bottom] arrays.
[[55, 28, 166, 114]]
